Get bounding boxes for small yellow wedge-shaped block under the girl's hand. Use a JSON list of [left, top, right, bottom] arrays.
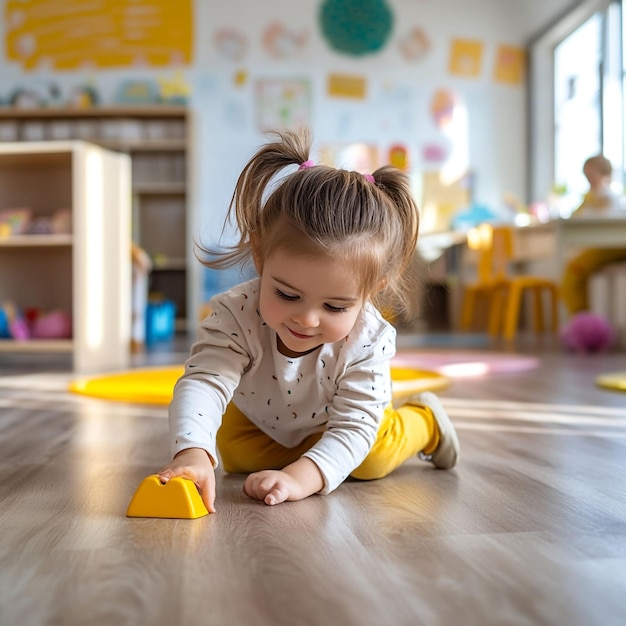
[[126, 474, 209, 519]]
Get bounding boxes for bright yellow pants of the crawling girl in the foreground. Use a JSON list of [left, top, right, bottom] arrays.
[[217, 403, 439, 480]]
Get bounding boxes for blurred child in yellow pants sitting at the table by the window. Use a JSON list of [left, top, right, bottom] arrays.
[[561, 155, 626, 315]]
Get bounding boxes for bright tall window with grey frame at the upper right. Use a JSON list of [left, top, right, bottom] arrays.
[[529, 0, 626, 212]]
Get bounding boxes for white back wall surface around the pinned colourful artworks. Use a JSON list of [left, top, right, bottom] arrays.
[[0, 0, 566, 310]]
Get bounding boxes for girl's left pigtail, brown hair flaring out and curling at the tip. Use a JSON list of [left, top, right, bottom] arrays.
[[196, 129, 312, 269]]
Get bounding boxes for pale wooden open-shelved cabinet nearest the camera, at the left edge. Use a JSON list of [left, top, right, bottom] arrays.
[[0, 141, 131, 372]]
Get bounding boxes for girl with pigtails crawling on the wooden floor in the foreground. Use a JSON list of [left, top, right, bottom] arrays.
[[159, 132, 459, 512]]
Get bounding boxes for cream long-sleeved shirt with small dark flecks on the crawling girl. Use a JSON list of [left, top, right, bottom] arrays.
[[170, 278, 396, 493]]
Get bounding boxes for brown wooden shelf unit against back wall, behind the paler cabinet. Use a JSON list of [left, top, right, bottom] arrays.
[[0, 106, 190, 330]]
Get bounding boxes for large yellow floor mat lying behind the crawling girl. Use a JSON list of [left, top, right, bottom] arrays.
[[69, 365, 450, 405]]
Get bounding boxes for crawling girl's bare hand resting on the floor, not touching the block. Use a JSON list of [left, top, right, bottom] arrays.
[[243, 457, 324, 505]]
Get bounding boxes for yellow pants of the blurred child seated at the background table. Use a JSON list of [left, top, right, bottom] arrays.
[[561, 248, 626, 315]]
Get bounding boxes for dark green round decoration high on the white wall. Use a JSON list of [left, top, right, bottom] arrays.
[[320, 0, 393, 56]]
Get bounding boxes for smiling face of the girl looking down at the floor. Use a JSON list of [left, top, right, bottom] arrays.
[[257, 249, 364, 356]]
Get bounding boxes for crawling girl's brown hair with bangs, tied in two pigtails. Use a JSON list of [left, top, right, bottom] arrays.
[[198, 130, 419, 312]]
